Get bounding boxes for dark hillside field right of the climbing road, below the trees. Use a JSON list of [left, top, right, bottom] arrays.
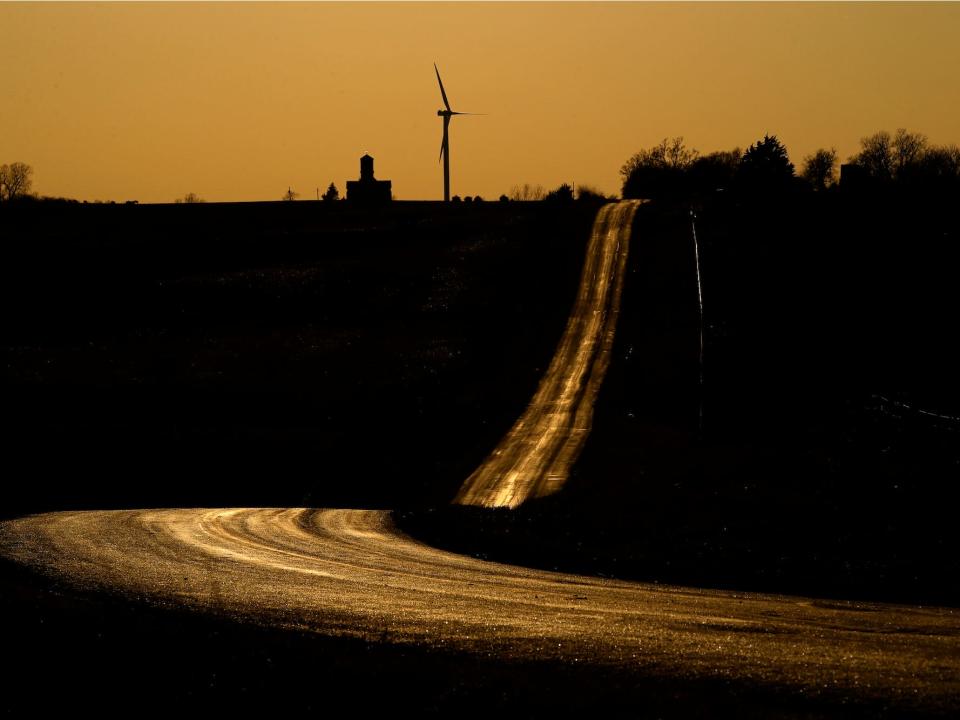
[[401, 195, 960, 606]]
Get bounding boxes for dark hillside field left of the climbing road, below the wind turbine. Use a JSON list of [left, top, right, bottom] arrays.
[[2, 203, 593, 515]]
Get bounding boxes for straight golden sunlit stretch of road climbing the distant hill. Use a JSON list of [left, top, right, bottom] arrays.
[[454, 200, 640, 507]]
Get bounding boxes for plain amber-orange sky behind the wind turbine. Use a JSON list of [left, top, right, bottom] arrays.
[[0, 2, 960, 202]]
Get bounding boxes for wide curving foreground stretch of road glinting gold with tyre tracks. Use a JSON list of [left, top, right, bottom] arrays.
[[0, 509, 960, 710]]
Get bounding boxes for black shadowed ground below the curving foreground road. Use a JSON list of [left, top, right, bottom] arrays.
[[0, 567, 876, 718]]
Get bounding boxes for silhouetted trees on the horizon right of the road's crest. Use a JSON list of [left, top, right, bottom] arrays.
[[620, 128, 960, 198]]
